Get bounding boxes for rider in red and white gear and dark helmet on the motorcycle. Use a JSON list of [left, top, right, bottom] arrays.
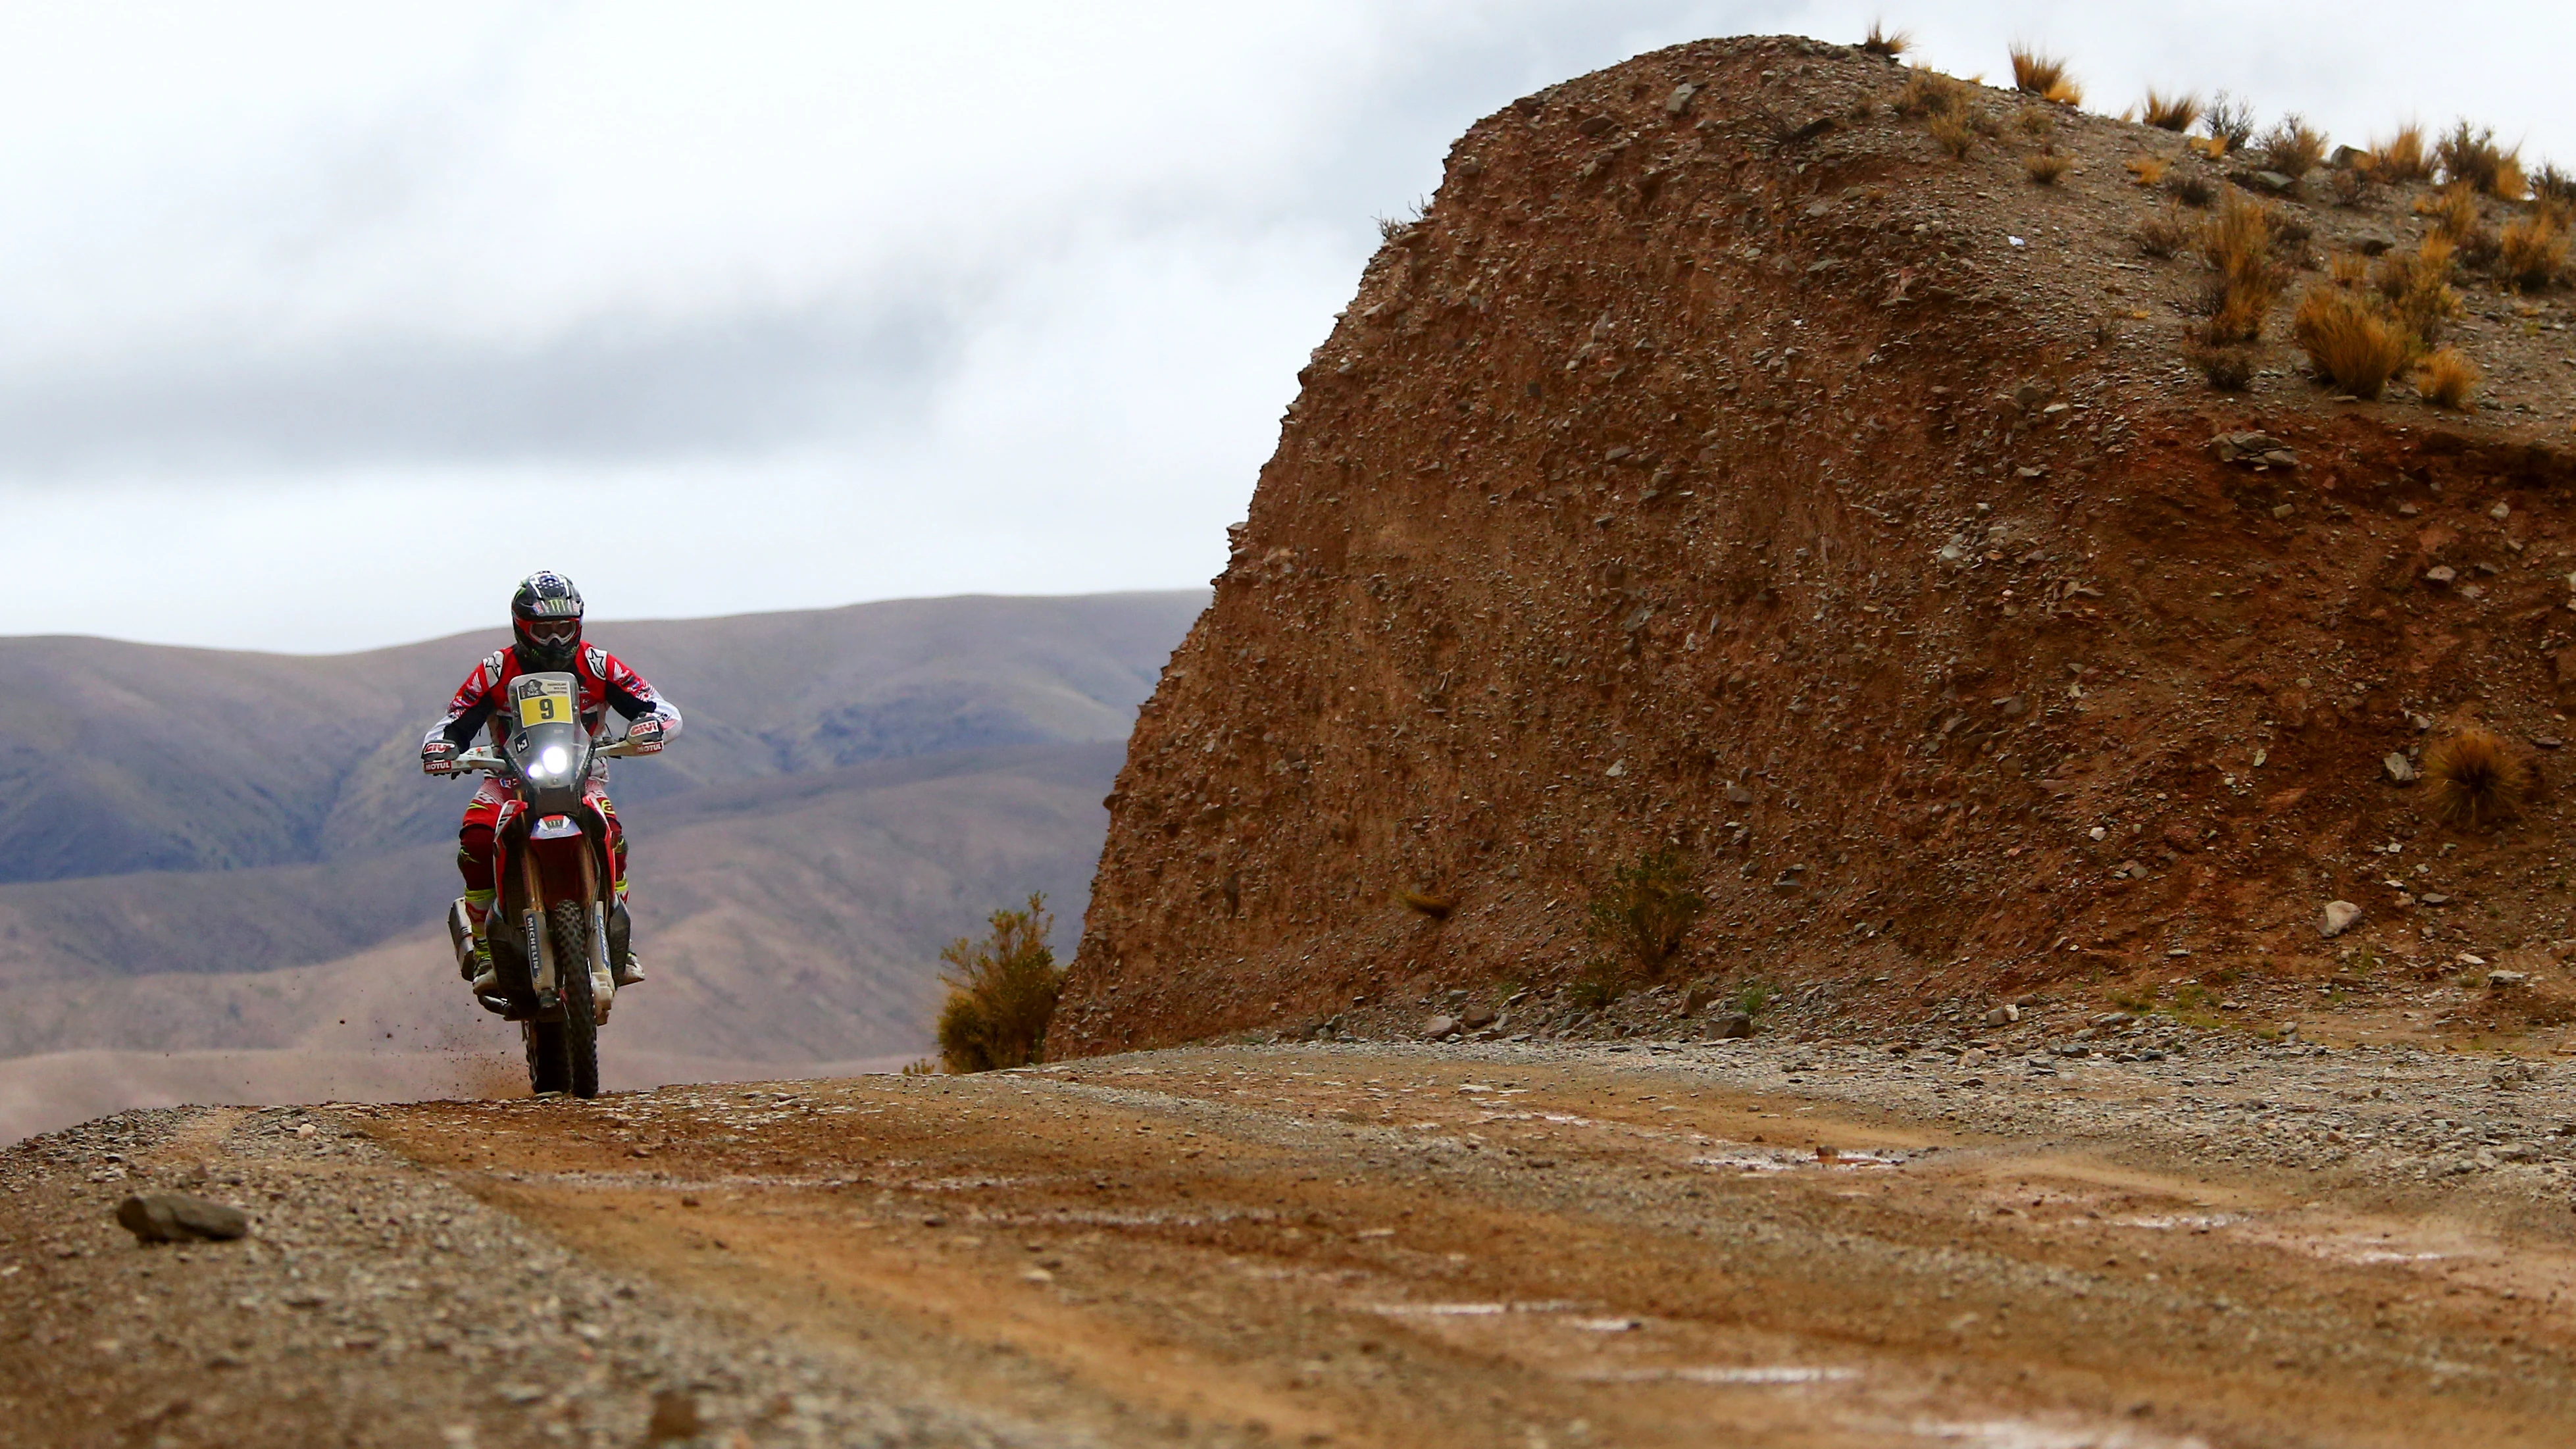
[[420, 570, 680, 988]]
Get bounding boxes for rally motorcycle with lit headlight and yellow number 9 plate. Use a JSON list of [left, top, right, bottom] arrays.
[[448, 673, 644, 1096]]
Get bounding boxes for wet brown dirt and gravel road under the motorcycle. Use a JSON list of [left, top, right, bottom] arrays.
[[0, 1042, 2576, 1449]]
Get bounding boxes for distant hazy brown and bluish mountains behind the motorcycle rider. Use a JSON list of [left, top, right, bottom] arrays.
[[0, 590, 1205, 1140]]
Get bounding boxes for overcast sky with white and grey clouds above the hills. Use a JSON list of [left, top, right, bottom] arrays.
[[15, 0, 2576, 652]]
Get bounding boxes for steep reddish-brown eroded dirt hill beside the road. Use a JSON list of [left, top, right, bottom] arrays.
[[1051, 39, 2576, 1057]]
